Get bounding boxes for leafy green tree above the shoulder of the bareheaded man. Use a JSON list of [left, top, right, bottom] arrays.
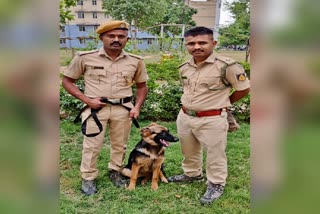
[[219, 0, 250, 61]]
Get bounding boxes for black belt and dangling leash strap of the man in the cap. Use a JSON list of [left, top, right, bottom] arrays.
[[73, 97, 140, 137]]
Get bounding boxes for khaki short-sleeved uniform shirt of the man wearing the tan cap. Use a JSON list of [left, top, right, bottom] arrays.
[[64, 47, 149, 99]]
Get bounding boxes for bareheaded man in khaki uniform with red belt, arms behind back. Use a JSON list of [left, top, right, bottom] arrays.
[[168, 27, 250, 203]]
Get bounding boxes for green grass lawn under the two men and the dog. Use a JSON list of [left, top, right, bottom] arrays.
[[60, 120, 250, 214]]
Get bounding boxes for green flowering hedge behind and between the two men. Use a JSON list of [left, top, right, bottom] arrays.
[[60, 56, 250, 122]]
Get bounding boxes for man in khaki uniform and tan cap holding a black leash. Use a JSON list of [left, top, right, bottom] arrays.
[[62, 21, 148, 195]]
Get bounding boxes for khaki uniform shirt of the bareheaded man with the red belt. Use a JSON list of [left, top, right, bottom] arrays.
[[180, 54, 250, 111]]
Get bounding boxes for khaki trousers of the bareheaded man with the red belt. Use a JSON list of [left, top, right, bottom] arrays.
[[177, 110, 229, 186]]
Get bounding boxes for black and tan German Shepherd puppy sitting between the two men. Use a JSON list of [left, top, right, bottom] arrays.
[[122, 123, 179, 190]]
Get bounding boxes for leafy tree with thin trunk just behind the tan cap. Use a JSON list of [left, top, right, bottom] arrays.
[[103, 0, 167, 49]]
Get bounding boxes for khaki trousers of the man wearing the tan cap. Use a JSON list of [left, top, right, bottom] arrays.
[[80, 104, 131, 180]]
